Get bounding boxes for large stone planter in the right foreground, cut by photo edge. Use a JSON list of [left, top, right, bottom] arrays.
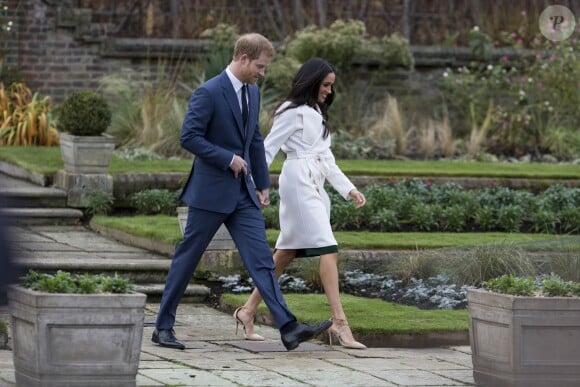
[[467, 289, 580, 387]]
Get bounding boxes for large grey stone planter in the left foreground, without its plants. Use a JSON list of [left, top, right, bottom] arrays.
[[8, 286, 146, 387]]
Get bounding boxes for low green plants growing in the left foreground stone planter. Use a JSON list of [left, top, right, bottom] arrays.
[[20, 270, 133, 294]]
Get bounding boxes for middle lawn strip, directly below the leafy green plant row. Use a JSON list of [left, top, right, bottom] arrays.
[[91, 215, 579, 250]]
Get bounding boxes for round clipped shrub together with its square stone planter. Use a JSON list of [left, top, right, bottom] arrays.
[[58, 90, 115, 174]]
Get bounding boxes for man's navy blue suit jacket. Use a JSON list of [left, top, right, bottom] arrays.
[[180, 71, 270, 213]]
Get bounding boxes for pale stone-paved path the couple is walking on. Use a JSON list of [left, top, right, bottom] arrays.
[[0, 226, 474, 387]]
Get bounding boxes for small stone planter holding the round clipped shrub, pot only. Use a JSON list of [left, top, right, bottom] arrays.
[[60, 132, 115, 174]]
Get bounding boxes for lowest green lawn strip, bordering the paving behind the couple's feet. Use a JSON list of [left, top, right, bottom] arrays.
[[221, 293, 468, 334]]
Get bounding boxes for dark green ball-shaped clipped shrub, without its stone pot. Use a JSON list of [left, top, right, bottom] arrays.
[[58, 90, 112, 136]]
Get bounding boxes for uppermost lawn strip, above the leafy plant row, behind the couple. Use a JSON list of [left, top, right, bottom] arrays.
[[0, 147, 580, 179]]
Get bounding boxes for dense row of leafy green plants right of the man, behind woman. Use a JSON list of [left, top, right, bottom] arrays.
[[264, 179, 580, 234]]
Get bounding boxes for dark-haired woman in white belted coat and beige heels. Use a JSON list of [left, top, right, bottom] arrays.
[[234, 58, 366, 349]]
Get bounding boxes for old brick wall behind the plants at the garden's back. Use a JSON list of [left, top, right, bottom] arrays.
[[0, 0, 533, 103]]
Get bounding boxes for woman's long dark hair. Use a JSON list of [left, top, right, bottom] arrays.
[[276, 58, 336, 138]]
